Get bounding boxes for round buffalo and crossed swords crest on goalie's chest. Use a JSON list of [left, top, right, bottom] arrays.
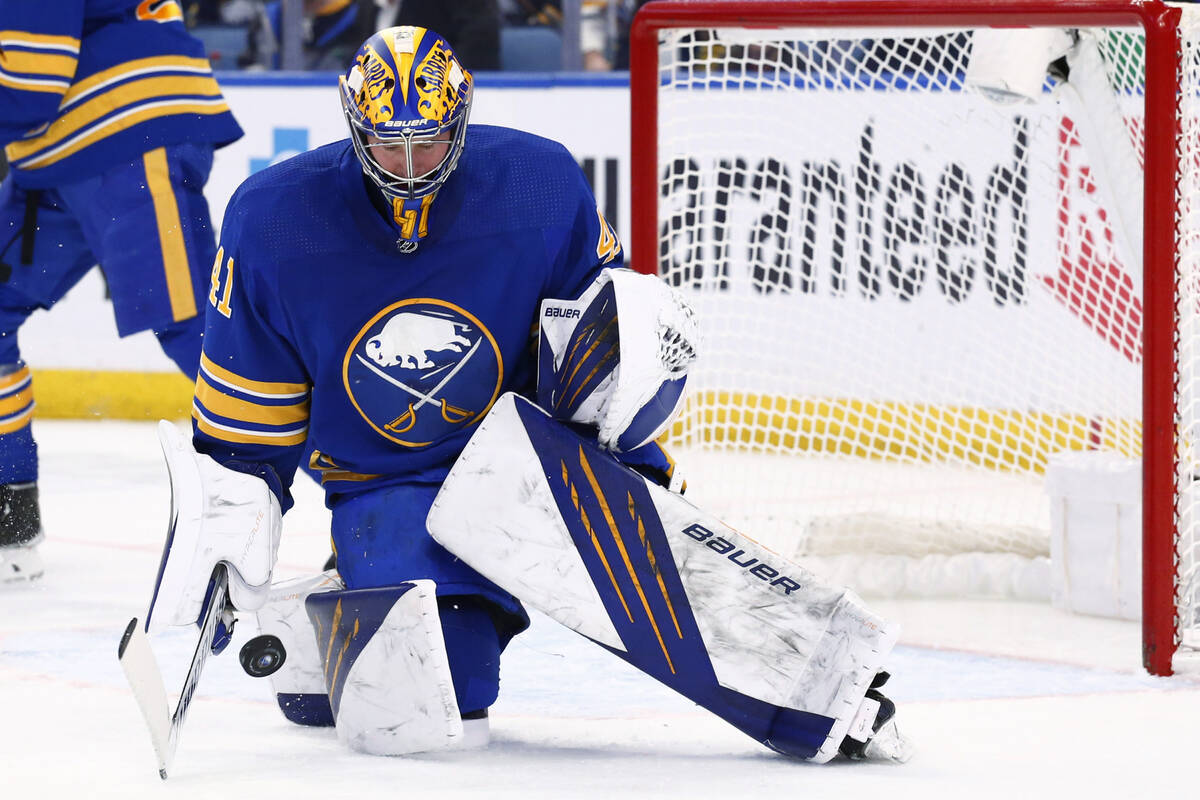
[[342, 297, 504, 447]]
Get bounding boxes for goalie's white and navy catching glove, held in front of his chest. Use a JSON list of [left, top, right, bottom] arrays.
[[538, 269, 700, 452]]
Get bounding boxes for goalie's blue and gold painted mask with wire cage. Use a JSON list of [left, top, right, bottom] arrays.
[[338, 25, 474, 252]]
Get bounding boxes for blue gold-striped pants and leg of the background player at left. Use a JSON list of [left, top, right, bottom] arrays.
[[0, 145, 215, 579]]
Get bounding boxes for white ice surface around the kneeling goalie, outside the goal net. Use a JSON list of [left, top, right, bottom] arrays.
[[0, 421, 1200, 800]]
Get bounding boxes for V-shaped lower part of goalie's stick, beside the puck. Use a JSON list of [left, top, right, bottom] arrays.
[[116, 564, 229, 781]]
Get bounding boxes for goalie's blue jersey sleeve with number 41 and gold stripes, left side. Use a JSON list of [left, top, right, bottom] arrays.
[[192, 197, 312, 510]]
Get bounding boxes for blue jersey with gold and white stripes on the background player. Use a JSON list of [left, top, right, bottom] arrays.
[[0, 0, 242, 188]]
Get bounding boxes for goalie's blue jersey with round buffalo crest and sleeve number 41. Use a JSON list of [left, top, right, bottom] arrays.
[[193, 126, 622, 507]]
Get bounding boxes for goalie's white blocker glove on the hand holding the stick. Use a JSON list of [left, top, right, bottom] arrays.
[[146, 420, 283, 632]]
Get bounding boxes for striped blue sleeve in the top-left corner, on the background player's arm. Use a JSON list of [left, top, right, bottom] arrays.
[[0, 0, 84, 144]]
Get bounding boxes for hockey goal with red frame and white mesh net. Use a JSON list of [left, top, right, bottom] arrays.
[[631, 0, 1200, 670]]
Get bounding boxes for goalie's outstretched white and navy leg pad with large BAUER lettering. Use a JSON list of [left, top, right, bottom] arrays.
[[427, 393, 911, 763]]
